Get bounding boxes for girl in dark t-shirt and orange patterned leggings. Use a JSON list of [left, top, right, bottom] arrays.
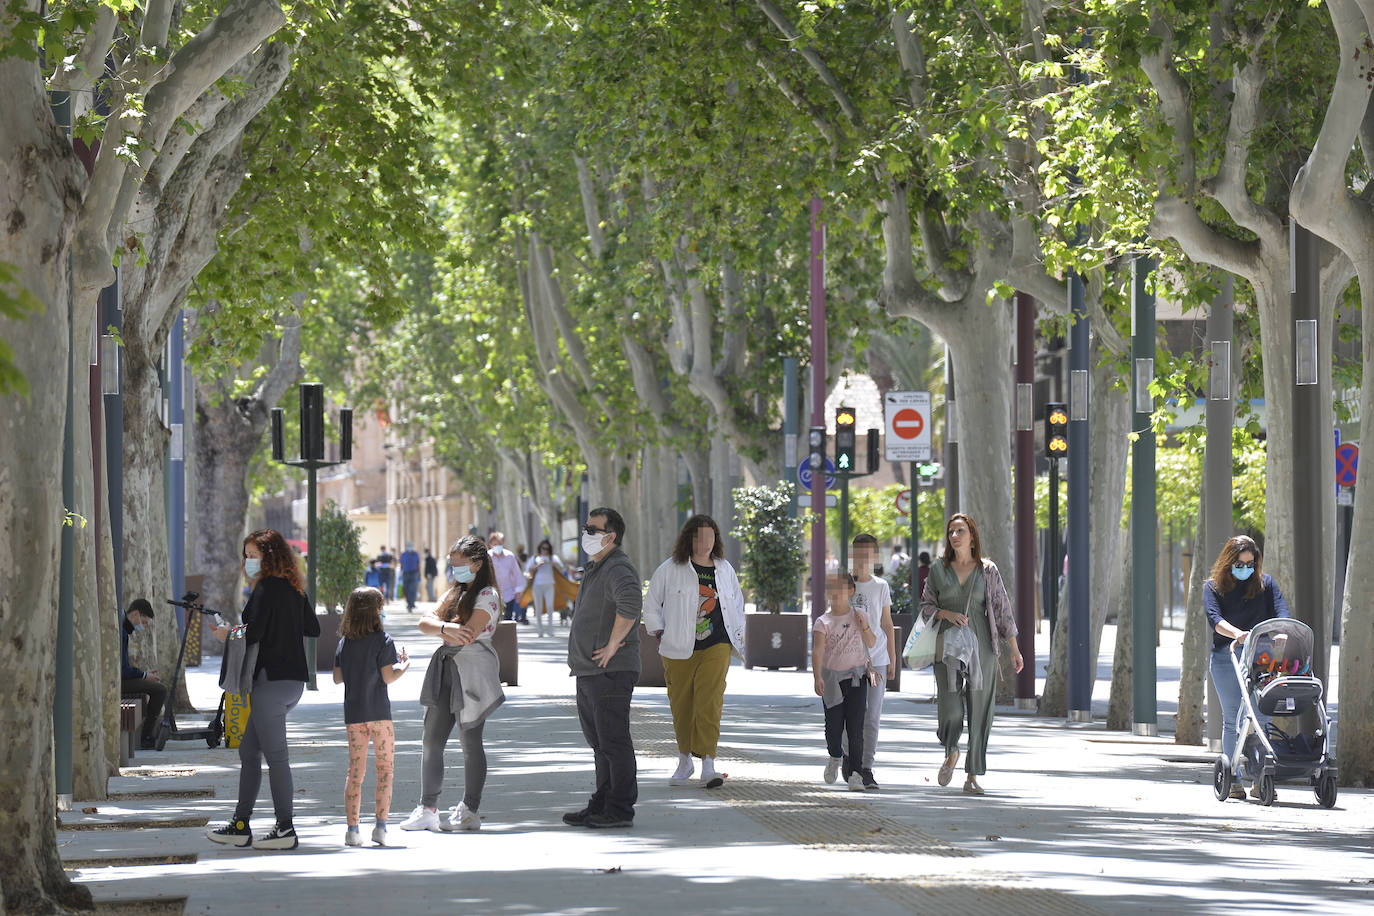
[[334, 586, 411, 846]]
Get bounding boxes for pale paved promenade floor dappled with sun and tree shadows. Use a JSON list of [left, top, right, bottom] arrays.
[[59, 604, 1374, 916]]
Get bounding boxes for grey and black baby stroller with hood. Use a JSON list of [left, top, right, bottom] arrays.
[[1212, 617, 1337, 808]]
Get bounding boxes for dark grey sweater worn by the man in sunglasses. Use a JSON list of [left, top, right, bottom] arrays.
[[567, 547, 644, 677]]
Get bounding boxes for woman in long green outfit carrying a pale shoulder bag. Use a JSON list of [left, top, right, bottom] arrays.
[[921, 512, 1024, 795]]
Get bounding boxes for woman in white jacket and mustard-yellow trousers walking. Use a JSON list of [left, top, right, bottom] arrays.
[[644, 515, 745, 788]]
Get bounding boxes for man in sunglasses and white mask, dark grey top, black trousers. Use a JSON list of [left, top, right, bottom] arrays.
[[563, 508, 644, 827]]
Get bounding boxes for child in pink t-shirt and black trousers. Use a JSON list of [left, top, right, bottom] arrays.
[[811, 573, 878, 792]]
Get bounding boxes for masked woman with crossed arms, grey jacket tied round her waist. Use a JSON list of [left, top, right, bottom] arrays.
[[401, 534, 506, 832]]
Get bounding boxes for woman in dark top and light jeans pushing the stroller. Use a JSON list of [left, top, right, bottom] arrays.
[[1202, 534, 1290, 798]]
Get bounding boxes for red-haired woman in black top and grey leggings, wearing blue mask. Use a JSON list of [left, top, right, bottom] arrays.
[[209, 529, 320, 849]]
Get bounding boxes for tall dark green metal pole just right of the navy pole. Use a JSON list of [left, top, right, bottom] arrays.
[[1131, 255, 1158, 735]]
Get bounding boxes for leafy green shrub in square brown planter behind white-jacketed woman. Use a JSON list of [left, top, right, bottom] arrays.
[[734, 483, 811, 672]]
